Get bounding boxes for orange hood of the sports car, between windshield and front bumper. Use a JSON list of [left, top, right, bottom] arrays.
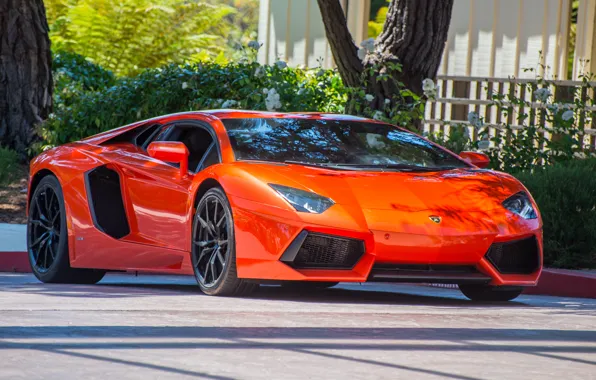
[[235, 164, 523, 212]]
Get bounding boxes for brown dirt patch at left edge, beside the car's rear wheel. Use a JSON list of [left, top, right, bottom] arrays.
[[0, 167, 27, 224]]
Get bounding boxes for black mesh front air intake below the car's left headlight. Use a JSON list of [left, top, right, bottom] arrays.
[[289, 232, 364, 269]]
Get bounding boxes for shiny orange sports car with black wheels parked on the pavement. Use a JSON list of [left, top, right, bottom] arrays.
[[27, 110, 542, 301]]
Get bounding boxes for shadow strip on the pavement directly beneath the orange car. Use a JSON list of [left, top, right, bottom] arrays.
[[0, 274, 596, 315]]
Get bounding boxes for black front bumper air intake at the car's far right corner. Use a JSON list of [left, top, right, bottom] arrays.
[[486, 236, 540, 274]]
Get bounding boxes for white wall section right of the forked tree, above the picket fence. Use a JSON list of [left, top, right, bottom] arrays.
[[439, 0, 570, 78]]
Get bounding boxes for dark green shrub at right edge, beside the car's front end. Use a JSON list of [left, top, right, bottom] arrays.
[[516, 159, 596, 269]]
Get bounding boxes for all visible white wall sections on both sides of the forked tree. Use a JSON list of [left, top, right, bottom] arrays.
[[259, 0, 584, 78]]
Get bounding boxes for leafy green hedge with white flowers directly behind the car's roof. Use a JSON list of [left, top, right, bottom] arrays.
[[36, 58, 346, 150]]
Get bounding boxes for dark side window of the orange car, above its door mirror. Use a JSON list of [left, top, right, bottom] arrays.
[[155, 124, 219, 173]]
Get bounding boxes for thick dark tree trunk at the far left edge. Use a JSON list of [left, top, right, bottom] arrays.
[[0, 0, 52, 159]]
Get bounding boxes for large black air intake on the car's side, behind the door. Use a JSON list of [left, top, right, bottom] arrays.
[[86, 166, 130, 239]]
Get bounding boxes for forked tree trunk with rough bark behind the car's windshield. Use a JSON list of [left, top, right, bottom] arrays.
[[318, 0, 453, 99]]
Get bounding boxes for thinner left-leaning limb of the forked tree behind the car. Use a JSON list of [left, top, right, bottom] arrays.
[[317, 0, 364, 87]]
